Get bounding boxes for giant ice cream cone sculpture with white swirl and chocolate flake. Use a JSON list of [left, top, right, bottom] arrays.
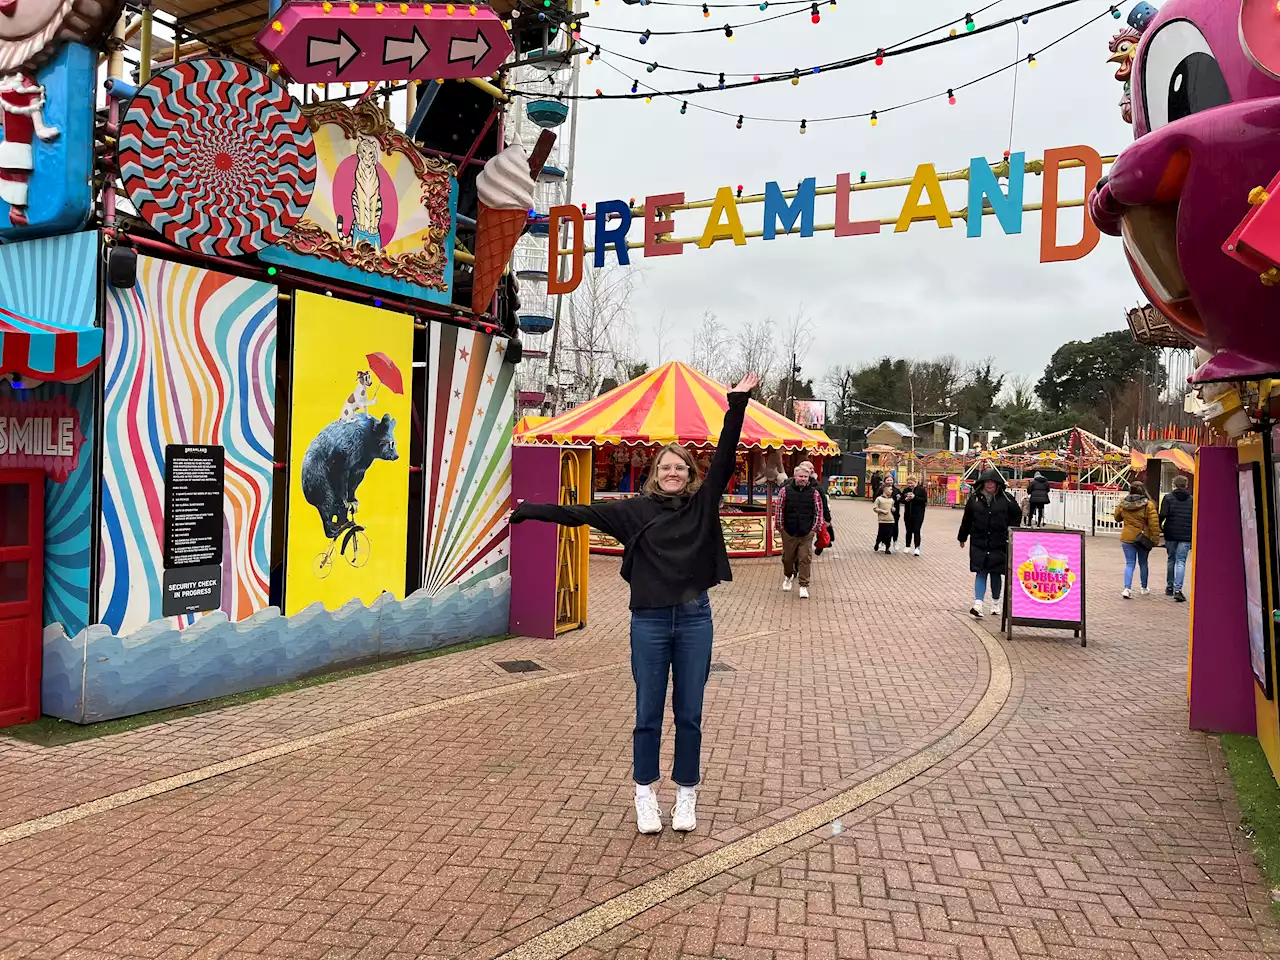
[[471, 131, 556, 314]]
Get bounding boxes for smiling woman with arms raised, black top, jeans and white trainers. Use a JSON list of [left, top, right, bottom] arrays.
[[511, 374, 760, 833]]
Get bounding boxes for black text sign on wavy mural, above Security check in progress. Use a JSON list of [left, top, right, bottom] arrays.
[[164, 443, 225, 570]]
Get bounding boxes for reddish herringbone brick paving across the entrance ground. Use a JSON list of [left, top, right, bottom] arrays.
[[0, 503, 1280, 960]]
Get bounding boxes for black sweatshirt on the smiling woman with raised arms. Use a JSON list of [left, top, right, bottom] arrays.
[[511, 393, 750, 611]]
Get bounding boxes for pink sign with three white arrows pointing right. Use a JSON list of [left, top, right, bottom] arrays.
[[257, 0, 512, 83]]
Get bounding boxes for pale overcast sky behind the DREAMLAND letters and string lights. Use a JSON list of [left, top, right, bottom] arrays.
[[562, 0, 1139, 391]]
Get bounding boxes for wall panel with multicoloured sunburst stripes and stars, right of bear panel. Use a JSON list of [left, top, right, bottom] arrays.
[[422, 323, 516, 595]]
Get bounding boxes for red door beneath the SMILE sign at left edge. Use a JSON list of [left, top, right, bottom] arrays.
[[0, 470, 45, 727]]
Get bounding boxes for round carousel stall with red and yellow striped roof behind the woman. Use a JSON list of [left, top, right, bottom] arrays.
[[515, 361, 840, 557]]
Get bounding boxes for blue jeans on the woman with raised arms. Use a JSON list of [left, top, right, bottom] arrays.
[[631, 593, 714, 787]]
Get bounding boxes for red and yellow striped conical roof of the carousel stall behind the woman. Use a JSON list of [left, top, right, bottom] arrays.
[[516, 361, 840, 457]]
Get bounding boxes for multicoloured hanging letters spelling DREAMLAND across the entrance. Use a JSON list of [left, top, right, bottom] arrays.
[[547, 146, 1103, 293]]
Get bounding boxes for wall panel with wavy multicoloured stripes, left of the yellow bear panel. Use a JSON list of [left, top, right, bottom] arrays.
[[99, 257, 276, 635]]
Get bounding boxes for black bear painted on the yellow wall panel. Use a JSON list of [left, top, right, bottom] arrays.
[[302, 413, 399, 539]]
